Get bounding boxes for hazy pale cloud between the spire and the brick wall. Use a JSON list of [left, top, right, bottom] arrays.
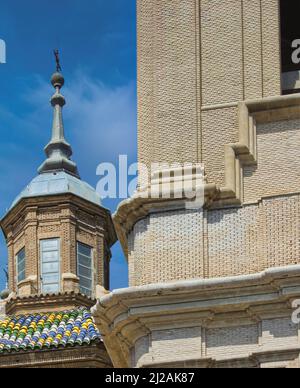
[[65, 73, 136, 158]]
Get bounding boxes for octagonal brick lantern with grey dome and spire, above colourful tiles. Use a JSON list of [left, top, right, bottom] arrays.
[[1, 68, 116, 314]]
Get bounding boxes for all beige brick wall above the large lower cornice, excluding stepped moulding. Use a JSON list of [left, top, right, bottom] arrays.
[[128, 0, 300, 285]]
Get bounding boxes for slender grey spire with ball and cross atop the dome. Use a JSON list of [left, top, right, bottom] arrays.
[[38, 50, 80, 178]]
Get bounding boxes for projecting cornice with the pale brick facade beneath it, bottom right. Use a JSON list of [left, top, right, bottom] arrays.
[[94, 265, 300, 368]]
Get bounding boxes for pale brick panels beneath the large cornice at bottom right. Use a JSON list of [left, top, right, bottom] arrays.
[[132, 317, 300, 368]]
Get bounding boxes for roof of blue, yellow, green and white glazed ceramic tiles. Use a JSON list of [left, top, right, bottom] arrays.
[[0, 308, 101, 353]]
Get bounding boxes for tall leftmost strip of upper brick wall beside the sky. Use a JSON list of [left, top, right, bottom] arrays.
[[137, 0, 199, 186]]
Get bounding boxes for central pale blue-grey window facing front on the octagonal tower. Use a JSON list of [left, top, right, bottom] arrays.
[[40, 238, 61, 294]]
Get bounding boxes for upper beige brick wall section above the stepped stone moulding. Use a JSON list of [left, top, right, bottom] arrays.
[[137, 0, 281, 185]]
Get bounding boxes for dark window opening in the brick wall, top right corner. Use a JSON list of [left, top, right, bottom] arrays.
[[280, 0, 300, 94]]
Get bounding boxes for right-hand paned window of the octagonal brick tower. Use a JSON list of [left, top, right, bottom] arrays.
[[76, 241, 94, 297]]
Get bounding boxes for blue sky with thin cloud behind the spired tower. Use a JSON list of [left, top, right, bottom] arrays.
[[0, 0, 137, 289]]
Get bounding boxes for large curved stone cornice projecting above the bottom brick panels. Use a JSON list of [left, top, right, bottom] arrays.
[[92, 265, 300, 367]]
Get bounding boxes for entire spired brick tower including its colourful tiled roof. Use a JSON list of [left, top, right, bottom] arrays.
[[0, 55, 116, 369]]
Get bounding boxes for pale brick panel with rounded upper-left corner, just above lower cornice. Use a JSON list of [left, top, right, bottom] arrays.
[[129, 210, 204, 285]]
